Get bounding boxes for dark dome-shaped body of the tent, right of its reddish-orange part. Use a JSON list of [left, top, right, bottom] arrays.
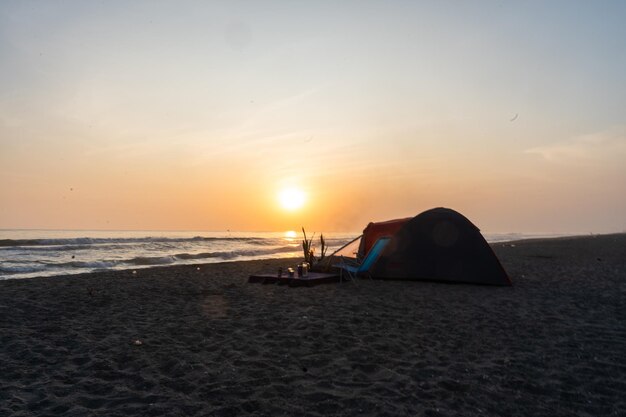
[[362, 208, 511, 285]]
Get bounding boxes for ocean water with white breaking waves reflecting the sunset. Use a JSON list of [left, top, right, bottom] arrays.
[[0, 230, 564, 280]]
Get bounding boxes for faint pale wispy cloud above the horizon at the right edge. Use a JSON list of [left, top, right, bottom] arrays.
[[524, 126, 626, 163]]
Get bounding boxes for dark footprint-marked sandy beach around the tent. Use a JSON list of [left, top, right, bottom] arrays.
[[0, 234, 626, 416]]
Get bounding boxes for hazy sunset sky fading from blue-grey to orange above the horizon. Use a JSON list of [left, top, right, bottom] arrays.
[[0, 0, 626, 233]]
